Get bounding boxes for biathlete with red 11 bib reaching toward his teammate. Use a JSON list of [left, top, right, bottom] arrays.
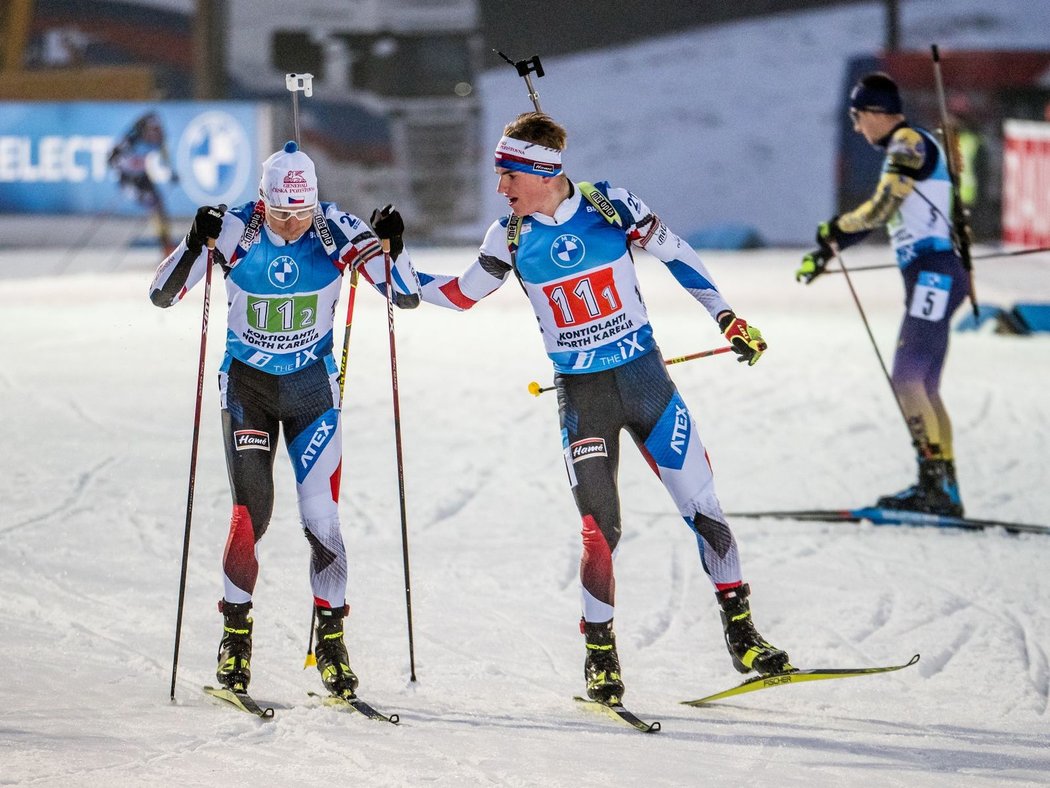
[[419, 112, 790, 703]]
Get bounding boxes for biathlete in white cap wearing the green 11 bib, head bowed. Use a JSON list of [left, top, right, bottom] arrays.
[[149, 142, 419, 693]]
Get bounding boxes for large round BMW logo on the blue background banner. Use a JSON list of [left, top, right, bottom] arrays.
[[176, 110, 253, 210]]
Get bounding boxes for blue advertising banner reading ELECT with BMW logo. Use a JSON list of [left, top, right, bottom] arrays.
[[0, 102, 271, 216]]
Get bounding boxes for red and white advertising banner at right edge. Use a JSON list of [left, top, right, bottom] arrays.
[[1003, 121, 1050, 248]]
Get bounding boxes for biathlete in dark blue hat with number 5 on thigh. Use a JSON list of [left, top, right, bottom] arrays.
[[795, 72, 969, 517]]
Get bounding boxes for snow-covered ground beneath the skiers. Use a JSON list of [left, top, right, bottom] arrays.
[[0, 243, 1050, 788]]
